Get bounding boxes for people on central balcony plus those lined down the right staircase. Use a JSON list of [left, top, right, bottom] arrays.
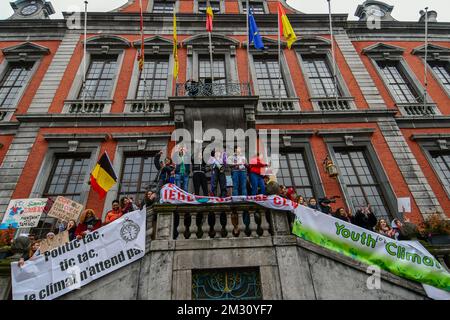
[[154, 146, 422, 240]]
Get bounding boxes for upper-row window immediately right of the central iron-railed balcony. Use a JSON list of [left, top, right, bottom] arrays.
[[254, 58, 287, 98]]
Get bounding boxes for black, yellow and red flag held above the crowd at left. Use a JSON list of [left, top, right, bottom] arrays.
[[90, 152, 117, 199]]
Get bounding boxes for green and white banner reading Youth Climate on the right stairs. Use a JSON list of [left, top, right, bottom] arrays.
[[292, 206, 450, 299]]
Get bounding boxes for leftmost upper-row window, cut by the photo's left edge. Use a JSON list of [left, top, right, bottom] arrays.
[[0, 62, 34, 108]]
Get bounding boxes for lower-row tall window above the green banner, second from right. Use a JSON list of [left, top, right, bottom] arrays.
[[335, 149, 390, 219]]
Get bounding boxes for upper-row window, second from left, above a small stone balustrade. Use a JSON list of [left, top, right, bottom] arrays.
[[79, 56, 117, 99]]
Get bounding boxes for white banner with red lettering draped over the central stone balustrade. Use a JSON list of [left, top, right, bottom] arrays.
[[160, 184, 298, 212]]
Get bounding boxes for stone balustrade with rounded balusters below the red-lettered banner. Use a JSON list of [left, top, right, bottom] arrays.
[[151, 204, 274, 240]]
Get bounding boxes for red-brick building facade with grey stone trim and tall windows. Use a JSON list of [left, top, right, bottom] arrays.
[[0, 0, 450, 298]]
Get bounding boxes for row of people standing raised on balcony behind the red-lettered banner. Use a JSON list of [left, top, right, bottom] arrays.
[[154, 146, 268, 197]]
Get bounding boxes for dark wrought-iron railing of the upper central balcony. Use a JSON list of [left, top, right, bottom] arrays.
[[176, 82, 251, 97]]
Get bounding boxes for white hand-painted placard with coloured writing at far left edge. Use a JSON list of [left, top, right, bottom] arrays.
[[1, 198, 48, 229]]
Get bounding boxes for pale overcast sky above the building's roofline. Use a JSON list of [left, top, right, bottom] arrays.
[[0, 0, 450, 21]]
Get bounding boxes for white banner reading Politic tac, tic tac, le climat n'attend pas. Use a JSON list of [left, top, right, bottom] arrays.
[[11, 210, 146, 300]]
